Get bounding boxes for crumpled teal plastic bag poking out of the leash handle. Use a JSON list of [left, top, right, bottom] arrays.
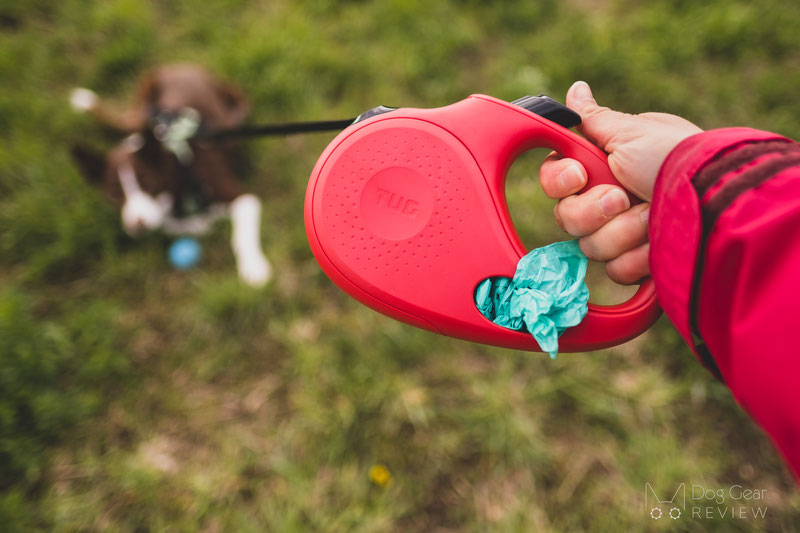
[[475, 241, 589, 358]]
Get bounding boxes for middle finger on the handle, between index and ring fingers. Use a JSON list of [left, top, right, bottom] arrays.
[[555, 185, 631, 237]]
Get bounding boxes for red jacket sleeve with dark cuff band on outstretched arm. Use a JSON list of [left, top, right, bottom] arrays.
[[650, 128, 800, 479]]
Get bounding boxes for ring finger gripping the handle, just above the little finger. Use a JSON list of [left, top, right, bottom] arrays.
[[579, 204, 650, 261]]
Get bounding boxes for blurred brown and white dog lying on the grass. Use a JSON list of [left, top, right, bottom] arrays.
[[70, 65, 271, 286]]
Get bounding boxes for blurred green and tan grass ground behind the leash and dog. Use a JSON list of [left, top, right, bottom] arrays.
[[0, 0, 800, 532]]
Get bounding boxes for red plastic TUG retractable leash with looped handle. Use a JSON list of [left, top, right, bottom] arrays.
[[305, 95, 661, 352]]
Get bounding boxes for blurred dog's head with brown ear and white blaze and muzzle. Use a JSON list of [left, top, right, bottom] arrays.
[[72, 134, 180, 236]]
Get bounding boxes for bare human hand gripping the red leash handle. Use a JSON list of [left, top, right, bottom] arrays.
[[539, 81, 702, 285]]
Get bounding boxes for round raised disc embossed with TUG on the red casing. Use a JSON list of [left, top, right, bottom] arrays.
[[361, 167, 434, 241]]
